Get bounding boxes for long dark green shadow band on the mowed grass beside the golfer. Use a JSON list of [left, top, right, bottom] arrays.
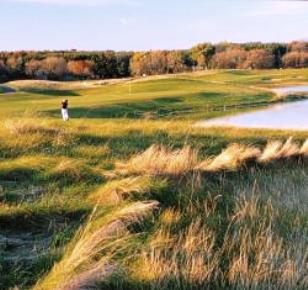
[[45, 92, 268, 119]]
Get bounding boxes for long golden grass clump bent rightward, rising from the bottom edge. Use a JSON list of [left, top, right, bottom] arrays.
[[34, 201, 158, 290]]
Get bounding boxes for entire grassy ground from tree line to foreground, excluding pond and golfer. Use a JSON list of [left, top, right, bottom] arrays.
[[0, 70, 308, 290]]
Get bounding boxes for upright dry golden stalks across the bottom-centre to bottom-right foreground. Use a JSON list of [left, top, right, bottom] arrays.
[[129, 197, 308, 289]]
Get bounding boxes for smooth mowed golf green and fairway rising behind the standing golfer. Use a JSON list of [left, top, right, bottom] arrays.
[[0, 70, 307, 118]]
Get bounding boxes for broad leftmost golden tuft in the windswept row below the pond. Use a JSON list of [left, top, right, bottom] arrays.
[[116, 145, 198, 175]]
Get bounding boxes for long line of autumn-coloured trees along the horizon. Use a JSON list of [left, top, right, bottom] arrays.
[[0, 41, 308, 82]]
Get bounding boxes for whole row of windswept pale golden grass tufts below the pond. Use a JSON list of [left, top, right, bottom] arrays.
[[116, 138, 308, 176]]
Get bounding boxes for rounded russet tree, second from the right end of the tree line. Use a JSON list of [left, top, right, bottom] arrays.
[[242, 49, 275, 69]]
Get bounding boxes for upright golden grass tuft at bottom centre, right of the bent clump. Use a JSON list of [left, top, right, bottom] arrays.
[[132, 219, 219, 289]]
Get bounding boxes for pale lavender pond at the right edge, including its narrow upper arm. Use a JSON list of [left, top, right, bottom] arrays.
[[196, 86, 308, 130]]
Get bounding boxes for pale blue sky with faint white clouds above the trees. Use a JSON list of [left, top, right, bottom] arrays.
[[0, 0, 308, 51]]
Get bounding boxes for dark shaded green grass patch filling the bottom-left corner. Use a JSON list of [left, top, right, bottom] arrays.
[[0, 216, 79, 289]]
